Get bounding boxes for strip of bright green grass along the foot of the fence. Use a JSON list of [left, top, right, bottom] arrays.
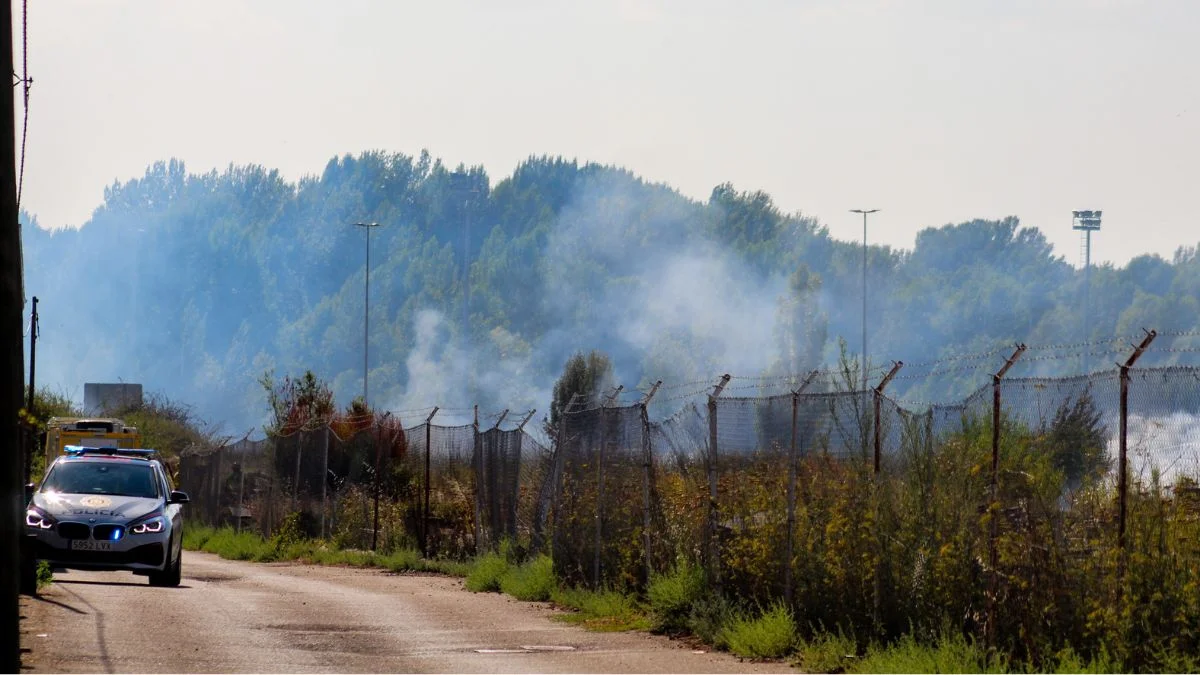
[[177, 525, 1196, 673]]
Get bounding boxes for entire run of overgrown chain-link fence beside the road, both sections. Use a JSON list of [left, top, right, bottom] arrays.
[[180, 362, 1200, 655]]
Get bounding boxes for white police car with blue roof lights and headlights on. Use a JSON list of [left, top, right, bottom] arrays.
[[25, 446, 188, 586]]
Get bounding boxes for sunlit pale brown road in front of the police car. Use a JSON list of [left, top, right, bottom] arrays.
[[20, 551, 790, 673]]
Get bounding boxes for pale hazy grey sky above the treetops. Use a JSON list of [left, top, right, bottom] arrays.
[[14, 0, 1200, 264]]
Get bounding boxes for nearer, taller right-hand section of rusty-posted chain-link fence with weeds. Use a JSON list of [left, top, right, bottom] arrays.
[[552, 368, 1200, 650]]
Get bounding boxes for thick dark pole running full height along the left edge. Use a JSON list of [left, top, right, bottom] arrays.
[[0, 0, 25, 673]]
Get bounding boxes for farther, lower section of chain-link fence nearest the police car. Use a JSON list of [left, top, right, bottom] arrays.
[[179, 410, 551, 557]]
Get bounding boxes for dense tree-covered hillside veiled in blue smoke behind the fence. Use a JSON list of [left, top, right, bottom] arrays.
[[23, 151, 1200, 429]]
